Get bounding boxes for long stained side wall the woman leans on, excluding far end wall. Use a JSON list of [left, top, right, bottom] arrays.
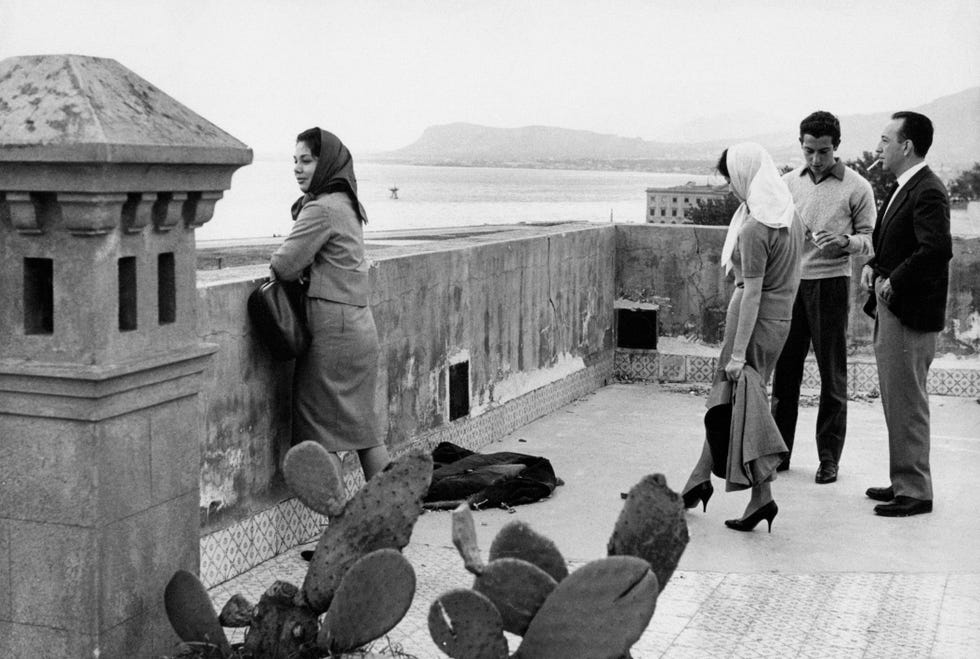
[[198, 225, 616, 529]]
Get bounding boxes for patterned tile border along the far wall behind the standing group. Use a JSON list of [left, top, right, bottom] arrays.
[[613, 348, 980, 398]]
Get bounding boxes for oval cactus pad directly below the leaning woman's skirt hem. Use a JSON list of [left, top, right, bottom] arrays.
[[282, 441, 345, 517]]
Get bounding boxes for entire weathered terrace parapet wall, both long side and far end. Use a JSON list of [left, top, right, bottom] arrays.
[[198, 225, 980, 530]]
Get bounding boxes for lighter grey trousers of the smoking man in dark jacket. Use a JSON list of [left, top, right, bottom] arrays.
[[874, 295, 938, 500]]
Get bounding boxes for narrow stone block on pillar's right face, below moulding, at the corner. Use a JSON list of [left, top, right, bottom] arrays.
[[95, 413, 151, 524]]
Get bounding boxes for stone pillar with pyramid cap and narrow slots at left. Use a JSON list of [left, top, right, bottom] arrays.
[[0, 55, 252, 658]]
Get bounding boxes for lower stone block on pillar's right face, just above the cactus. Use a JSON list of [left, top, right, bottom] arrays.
[[98, 491, 200, 629]]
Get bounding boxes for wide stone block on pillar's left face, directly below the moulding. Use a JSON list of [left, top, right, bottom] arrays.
[[0, 415, 98, 526]]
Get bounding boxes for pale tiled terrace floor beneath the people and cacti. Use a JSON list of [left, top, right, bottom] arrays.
[[211, 384, 980, 659]]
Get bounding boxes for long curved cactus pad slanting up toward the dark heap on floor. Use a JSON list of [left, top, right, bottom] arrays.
[[302, 452, 432, 614]]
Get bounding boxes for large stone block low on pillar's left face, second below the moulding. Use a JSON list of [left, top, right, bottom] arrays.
[[9, 520, 99, 632]]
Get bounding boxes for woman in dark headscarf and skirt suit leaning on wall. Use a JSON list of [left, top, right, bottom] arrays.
[[272, 128, 389, 480]]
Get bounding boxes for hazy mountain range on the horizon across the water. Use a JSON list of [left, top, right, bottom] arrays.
[[371, 87, 980, 171]]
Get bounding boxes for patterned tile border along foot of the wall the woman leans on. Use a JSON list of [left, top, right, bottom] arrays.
[[200, 350, 613, 588]]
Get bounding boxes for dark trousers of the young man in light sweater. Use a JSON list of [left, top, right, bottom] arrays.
[[772, 277, 851, 463]]
